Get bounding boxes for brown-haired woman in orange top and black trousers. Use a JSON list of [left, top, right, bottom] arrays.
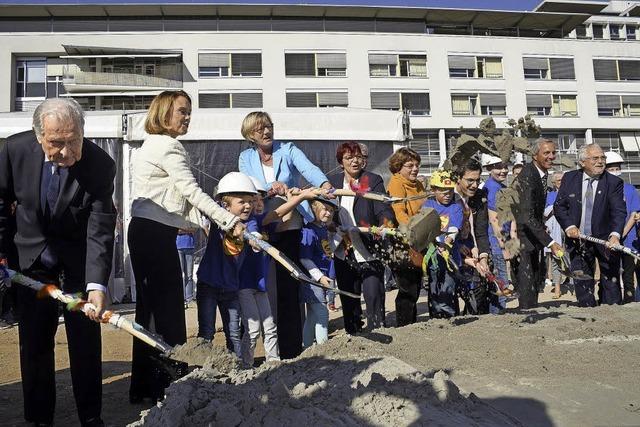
[[389, 147, 427, 326]]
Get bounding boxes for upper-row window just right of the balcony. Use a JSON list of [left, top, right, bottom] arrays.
[[198, 52, 262, 77]]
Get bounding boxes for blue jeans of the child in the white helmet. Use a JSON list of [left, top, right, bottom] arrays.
[[196, 282, 241, 357]]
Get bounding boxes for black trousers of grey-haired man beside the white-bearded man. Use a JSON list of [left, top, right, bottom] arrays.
[[511, 250, 546, 309]]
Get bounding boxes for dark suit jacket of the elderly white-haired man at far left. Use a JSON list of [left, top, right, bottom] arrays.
[[0, 131, 116, 290]]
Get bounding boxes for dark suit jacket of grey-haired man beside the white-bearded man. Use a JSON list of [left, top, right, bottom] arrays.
[[513, 163, 553, 251]]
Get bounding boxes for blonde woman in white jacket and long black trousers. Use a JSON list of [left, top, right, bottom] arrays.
[[128, 91, 244, 403]]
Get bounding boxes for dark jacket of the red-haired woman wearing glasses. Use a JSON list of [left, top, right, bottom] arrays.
[[330, 171, 396, 231]]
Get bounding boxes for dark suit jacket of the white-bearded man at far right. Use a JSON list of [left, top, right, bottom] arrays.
[[553, 170, 627, 244]]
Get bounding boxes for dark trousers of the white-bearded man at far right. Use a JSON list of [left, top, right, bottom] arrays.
[[569, 242, 622, 307]]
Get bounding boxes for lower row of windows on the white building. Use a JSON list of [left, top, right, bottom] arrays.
[[199, 91, 640, 117]]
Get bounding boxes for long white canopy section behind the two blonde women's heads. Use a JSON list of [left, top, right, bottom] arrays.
[[126, 108, 405, 142]]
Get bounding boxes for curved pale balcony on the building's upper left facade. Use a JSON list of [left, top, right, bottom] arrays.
[[62, 64, 182, 93]]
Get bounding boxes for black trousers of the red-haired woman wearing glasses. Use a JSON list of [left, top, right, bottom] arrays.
[[334, 258, 386, 334]]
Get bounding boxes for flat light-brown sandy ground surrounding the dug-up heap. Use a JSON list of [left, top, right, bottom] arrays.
[[0, 289, 640, 426]]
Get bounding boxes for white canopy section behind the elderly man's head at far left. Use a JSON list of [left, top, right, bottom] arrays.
[[0, 111, 123, 139]]
